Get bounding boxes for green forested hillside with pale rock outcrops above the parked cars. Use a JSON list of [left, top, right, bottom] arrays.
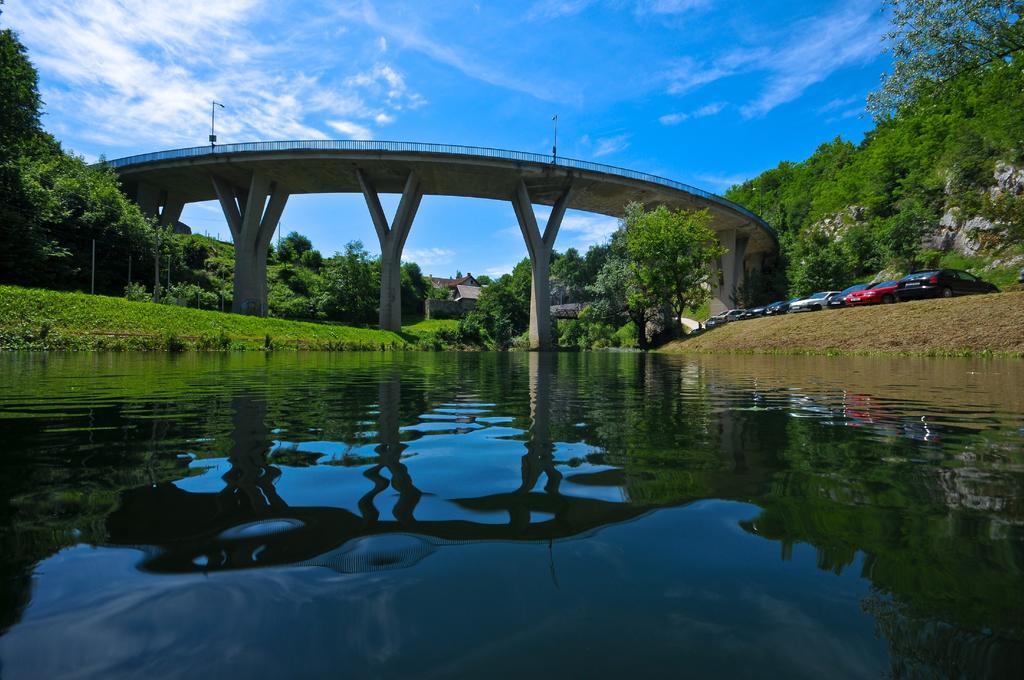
[[726, 58, 1024, 301]]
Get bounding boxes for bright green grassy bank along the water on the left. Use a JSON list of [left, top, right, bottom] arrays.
[[0, 286, 451, 350]]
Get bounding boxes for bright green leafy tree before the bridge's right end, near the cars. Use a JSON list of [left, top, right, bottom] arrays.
[[626, 204, 726, 335]]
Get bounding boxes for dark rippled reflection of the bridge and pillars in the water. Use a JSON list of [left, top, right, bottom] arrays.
[[108, 353, 651, 571]]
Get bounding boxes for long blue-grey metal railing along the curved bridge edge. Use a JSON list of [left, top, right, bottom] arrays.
[[106, 139, 774, 235]]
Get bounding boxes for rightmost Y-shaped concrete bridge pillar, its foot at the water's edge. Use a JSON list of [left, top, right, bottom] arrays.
[[512, 179, 572, 349]]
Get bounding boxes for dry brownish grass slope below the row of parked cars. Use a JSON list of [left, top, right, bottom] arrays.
[[663, 292, 1024, 356]]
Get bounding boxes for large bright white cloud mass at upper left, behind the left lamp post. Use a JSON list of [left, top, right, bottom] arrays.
[[4, 0, 422, 146]]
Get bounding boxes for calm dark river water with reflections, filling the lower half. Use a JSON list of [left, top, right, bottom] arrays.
[[0, 353, 1024, 678]]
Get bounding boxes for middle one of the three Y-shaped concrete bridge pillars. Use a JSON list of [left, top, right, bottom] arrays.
[[355, 170, 423, 333]]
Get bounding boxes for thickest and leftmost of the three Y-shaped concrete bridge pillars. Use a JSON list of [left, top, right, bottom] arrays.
[[213, 172, 288, 316]]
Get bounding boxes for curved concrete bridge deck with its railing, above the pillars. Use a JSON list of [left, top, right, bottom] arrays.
[[109, 140, 776, 252]]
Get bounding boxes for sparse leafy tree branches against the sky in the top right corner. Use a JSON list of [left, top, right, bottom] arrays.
[[867, 0, 1024, 118]]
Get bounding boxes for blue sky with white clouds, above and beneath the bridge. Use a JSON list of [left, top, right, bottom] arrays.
[[6, 0, 888, 274]]
